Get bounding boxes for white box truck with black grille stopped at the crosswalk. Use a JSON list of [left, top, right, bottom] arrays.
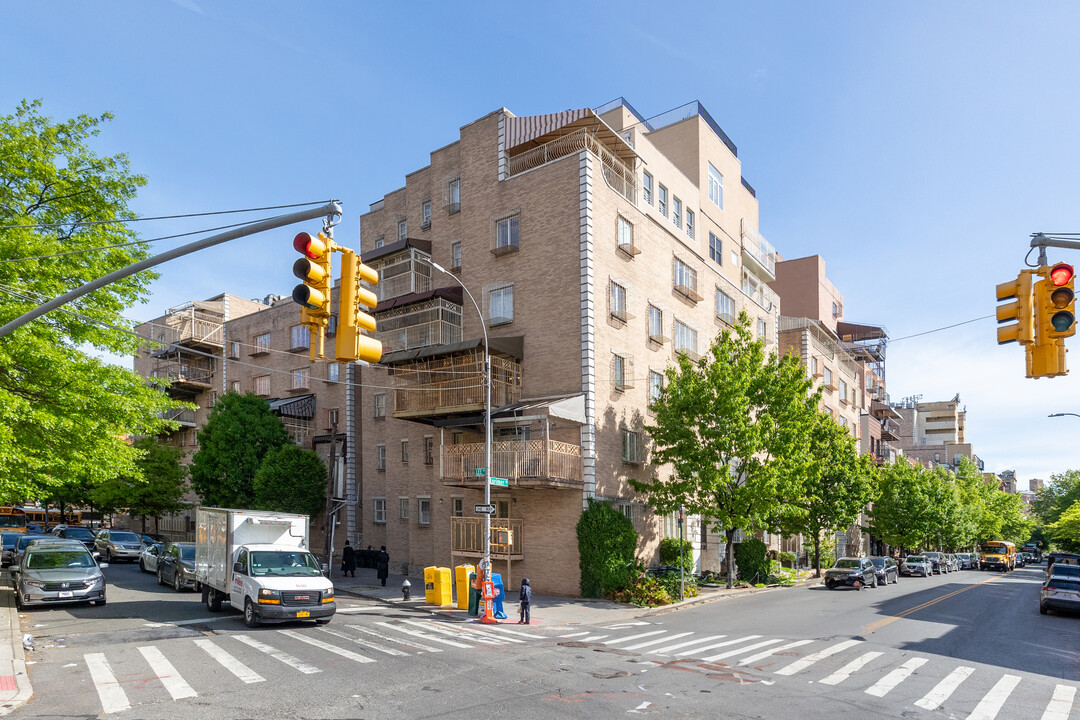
[[195, 507, 337, 627]]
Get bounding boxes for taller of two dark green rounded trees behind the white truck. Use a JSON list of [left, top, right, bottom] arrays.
[[191, 393, 292, 508]]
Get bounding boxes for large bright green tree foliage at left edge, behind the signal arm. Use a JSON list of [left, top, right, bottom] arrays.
[[0, 100, 177, 502]]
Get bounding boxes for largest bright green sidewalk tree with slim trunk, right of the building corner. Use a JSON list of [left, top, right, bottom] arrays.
[[631, 312, 819, 587]]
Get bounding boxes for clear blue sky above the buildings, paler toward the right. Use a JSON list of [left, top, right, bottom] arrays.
[[0, 0, 1080, 489]]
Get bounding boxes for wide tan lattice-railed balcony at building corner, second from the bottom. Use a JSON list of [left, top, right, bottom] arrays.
[[442, 439, 581, 489]]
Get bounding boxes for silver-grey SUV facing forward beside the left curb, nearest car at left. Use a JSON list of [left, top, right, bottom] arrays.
[[11, 543, 108, 608]]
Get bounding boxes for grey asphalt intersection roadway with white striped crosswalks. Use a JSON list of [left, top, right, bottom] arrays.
[[4, 565, 1080, 720]]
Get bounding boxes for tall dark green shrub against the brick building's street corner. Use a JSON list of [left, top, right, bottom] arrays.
[[577, 499, 637, 598]]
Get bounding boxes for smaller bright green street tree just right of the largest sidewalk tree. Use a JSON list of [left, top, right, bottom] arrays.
[[782, 411, 877, 578]]
